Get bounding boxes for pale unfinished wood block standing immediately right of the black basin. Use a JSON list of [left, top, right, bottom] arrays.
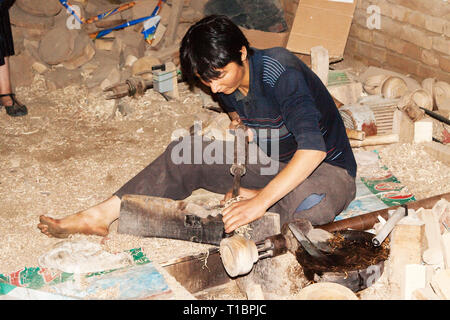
[[388, 224, 423, 298]]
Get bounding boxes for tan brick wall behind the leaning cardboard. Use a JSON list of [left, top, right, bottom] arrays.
[[280, 0, 450, 82]]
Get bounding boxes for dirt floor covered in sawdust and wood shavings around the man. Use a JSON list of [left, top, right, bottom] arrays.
[[0, 69, 450, 300]]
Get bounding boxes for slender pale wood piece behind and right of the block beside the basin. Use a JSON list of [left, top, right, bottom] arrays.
[[417, 209, 444, 265]]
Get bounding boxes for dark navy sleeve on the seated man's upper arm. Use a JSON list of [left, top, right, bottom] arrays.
[[273, 68, 326, 152]]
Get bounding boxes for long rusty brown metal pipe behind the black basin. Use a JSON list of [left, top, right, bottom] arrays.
[[317, 192, 450, 232]]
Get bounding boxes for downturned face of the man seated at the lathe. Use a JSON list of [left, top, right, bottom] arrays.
[[200, 62, 245, 94]]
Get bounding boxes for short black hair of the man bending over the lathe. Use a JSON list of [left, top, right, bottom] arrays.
[[180, 15, 252, 83]]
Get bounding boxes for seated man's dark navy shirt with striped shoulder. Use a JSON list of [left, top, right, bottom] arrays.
[[218, 48, 356, 177]]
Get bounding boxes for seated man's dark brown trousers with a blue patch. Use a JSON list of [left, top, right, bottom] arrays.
[[114, 136, 356, 225]]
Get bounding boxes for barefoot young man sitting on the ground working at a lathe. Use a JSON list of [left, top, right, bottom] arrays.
[[38, 16, 356, 237]]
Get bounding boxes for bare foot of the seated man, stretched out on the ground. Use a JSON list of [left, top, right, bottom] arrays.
[[38, 196, 120, 238]]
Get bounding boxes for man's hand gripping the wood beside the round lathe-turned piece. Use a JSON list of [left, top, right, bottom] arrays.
[[222, 195, 267, 233]]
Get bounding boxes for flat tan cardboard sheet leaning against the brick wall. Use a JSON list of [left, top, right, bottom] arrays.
[[286, 0, 356, 58]]
